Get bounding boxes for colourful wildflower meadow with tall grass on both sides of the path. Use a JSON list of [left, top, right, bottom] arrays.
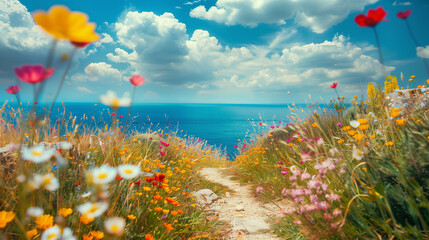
[[0, 3, 429, 240]]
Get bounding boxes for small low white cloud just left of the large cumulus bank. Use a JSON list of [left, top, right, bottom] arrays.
[[71, 62, 122, 82]]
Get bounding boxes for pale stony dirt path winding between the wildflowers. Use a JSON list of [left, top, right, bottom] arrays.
[[201, 168, 280, 240]]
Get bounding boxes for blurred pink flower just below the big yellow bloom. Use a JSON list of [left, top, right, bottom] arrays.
[[15, 65, 54, 84]]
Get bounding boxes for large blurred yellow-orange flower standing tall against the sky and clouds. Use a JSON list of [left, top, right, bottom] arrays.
[[33, 5, 99, 43]]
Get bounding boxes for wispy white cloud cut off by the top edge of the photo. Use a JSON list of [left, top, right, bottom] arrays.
[[190, 0, 378, 33]]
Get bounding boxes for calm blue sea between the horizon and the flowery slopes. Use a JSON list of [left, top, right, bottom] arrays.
[[7, 103, 334, 154]]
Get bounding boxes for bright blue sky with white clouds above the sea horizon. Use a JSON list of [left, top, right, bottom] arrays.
[[0, 0, 429, 104]]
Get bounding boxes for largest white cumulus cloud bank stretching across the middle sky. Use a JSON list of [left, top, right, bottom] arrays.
[[107, 12, 394, 93]]
